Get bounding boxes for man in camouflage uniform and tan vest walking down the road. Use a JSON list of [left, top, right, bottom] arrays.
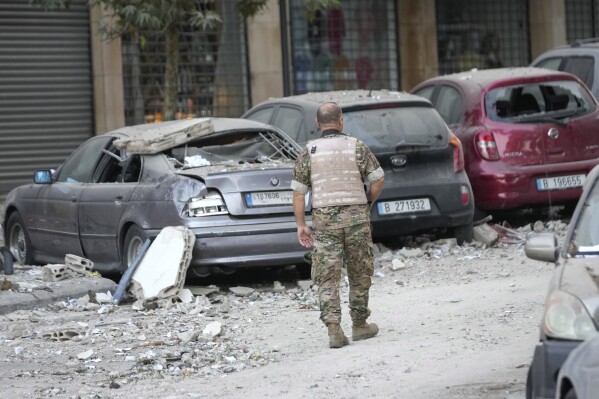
[[291, 103, 384, 348]]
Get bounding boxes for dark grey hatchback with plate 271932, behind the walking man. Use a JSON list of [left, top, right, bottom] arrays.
[[242, 90, 474, 245]]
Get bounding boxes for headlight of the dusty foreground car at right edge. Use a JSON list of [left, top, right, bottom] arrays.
[[543, 291, 597, 341]]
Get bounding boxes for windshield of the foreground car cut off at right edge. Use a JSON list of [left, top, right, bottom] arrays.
[[568, 180, 599, 256]]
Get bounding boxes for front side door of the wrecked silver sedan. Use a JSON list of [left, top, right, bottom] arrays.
[[35, 136, 111, 260]]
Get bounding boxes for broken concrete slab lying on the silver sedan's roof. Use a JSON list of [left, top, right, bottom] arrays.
[[114, 118, 214, 154]]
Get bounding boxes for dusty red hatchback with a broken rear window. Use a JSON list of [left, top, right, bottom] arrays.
[[412, 68, 599, 212]]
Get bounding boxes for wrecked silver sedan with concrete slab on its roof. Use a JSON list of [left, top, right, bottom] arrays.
[[4, 118, 309, 277]]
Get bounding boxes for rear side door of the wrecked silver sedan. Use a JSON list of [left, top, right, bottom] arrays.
[[78, 146, 141, 263]]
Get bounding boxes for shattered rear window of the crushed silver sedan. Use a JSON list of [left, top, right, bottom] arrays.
[[165, 131, 298, 169]]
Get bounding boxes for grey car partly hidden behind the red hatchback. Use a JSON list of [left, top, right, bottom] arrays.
[[530, 38, 599, 99]]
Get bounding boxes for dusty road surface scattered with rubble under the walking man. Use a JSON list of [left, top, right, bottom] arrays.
[[0, 222, 565, 399]]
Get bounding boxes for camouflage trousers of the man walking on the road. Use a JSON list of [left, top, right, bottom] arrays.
[[312, 223, 374, 325]]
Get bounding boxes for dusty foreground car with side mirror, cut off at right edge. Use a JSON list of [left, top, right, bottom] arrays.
[[525, 165, 599, 399]]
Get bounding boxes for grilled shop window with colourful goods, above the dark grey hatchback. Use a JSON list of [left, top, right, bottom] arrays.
[[287, 0, 399, 94]]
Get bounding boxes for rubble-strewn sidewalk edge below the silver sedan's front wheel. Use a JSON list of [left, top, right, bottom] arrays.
[[0, 265, 117, 315]]
